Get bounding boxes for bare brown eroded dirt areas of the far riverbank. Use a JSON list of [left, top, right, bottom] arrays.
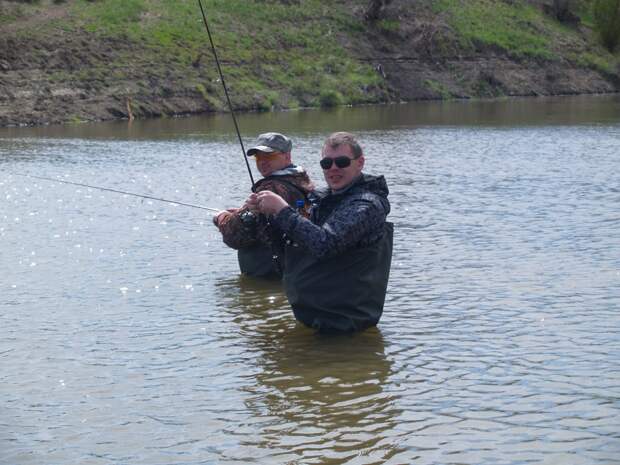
[[0, 0, 620, 126]]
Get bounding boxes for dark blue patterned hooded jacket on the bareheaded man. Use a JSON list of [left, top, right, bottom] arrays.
[[273, 174, 390, 259]]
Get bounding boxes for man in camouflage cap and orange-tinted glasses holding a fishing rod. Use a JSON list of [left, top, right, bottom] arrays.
[[213, 132, 314, 279]]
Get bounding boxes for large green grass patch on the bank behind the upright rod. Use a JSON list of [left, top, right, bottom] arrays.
[[60, 0, 386, 109]]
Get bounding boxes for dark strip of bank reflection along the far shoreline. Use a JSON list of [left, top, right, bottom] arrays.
[[0, 95, 620, 140]]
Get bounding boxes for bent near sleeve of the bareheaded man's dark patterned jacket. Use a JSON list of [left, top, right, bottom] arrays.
[[273, 197, 387, 259]]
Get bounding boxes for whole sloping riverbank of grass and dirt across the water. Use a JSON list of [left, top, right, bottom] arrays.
[[0, 0, 620, 126]]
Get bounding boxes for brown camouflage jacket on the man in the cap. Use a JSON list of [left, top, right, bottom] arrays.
[[217, 165, 314, 250]]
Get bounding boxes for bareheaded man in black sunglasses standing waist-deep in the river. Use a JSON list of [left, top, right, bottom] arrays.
[[246, 132, 393, 333]]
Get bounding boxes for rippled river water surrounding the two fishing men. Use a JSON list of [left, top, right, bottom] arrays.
[[0, 96, 620, 465]]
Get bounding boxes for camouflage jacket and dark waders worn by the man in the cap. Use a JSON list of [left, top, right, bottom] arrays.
[[217, 165, 314, 277]]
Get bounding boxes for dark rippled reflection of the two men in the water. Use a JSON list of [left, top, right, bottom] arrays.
[[217, 276, 399, 464]]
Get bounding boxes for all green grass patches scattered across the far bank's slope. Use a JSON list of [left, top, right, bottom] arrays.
[[0, 0, 620, 111]]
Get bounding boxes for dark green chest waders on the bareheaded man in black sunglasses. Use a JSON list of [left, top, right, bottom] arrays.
[[284, 222, 394, 333]]
